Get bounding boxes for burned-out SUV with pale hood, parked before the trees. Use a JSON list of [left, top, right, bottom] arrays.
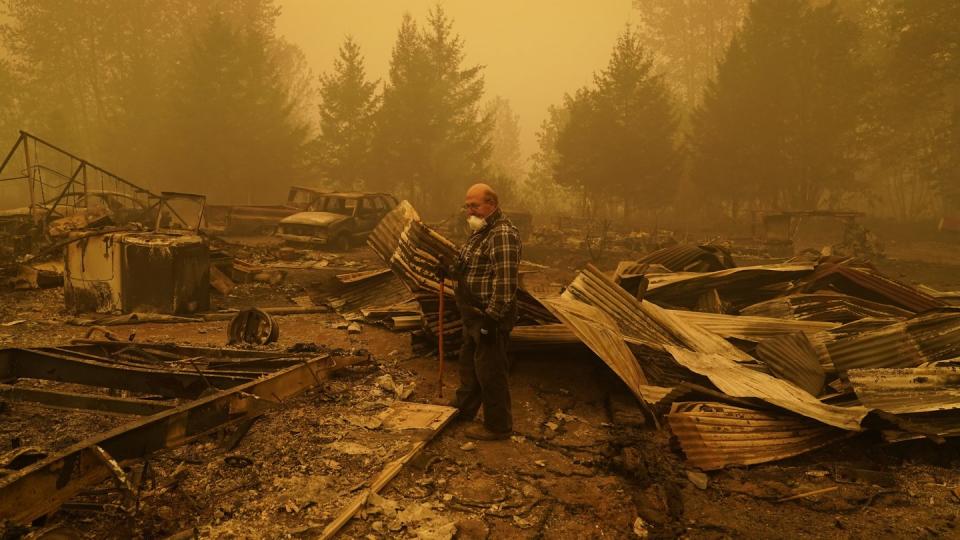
[[277, 193, 397, 251]]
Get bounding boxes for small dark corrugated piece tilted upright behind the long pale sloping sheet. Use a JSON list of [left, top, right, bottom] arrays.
[[757, 333, 827, 396]]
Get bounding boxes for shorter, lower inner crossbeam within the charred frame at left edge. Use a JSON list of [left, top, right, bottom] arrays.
[[0, 384, 173, 416]]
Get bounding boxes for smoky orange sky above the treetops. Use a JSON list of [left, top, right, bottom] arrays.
[[278, 0, 635, 167]]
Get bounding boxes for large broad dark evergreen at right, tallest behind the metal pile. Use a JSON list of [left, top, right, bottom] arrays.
[[691, 0, 871, 214]]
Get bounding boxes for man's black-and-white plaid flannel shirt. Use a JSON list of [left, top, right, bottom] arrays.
[[457, 208, 521, 321]]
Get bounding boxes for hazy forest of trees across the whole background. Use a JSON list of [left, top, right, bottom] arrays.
[[0, 0, 960, 228]]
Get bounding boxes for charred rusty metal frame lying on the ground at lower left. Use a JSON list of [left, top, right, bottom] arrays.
[[0, 340, 359, 525]]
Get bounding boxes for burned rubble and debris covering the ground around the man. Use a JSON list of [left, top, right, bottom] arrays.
[[0, 133, 960, 538]]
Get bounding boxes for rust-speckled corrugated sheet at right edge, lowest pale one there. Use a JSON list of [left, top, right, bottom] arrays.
[[847, 365, 960, 414]]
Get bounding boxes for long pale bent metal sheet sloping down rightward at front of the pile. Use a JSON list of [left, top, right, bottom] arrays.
[[670, 348, 869, 431]]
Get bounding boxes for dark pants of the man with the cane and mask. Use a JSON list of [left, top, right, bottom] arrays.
[[455, 316, 513, 433]]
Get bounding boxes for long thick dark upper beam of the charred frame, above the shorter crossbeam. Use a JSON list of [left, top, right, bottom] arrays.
[[0, 349, 249, 399]]
